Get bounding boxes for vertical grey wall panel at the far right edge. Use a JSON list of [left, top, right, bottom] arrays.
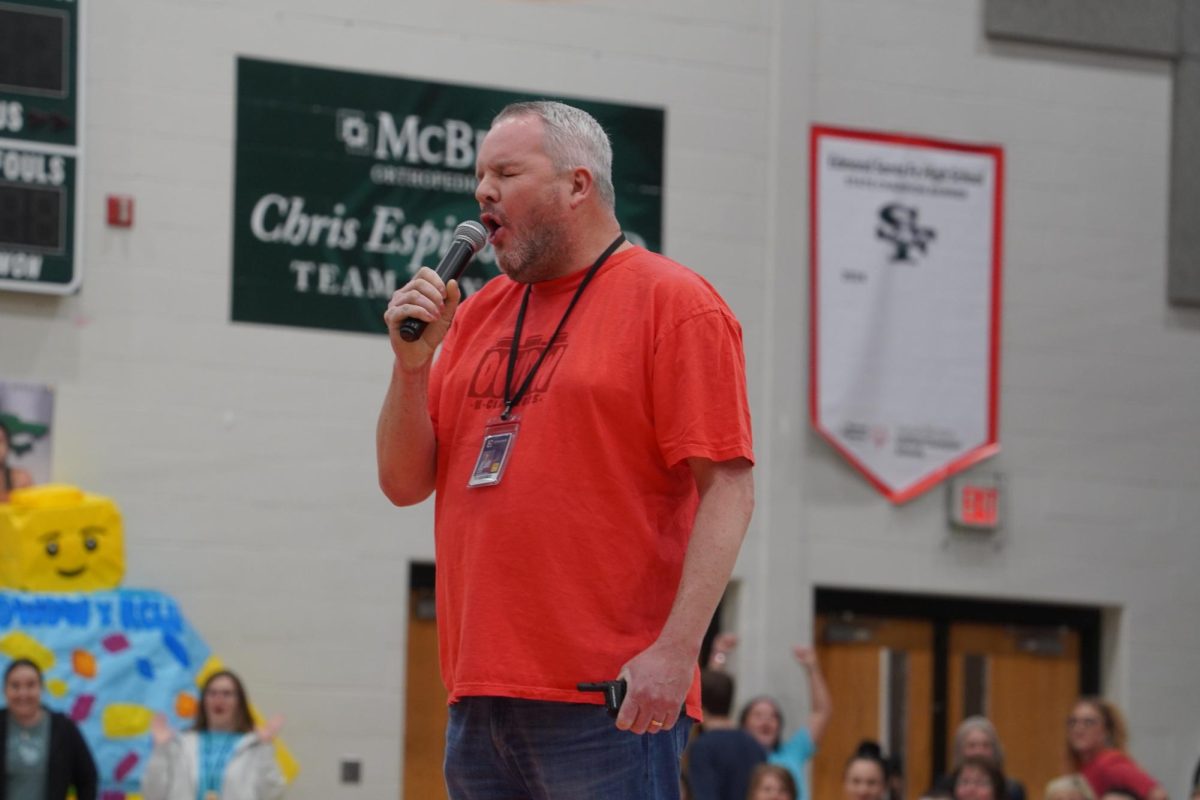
[[1166, 56, 1200, 306]]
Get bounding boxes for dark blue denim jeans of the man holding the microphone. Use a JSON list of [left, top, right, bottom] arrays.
[[445, 697, 691, 800]]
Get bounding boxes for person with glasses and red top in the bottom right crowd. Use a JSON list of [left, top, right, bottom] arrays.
[[1067, 697, 1166, 800]]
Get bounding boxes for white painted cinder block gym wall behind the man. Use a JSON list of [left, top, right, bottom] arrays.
[[0, 0, 1200, 800]]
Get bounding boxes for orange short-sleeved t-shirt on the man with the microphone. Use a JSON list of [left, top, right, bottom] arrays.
[[430, 247, 754, 718]]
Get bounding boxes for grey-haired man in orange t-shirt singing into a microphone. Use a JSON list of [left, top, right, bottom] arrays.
[[377, 102, 754, 800]]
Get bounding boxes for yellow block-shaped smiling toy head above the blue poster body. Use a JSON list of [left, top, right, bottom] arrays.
[[0, 485, 125, 591]]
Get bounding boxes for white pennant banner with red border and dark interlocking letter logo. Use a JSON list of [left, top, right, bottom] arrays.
[[810, 126, 1003, 503]]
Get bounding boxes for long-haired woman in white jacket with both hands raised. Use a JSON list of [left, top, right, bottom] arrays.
[[142, 670, 284, 800]]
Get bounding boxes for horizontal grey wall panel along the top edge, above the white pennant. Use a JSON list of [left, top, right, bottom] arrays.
[[984, 0, 1180, 56]]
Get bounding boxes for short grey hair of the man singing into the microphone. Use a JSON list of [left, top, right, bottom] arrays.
[[492, 100, 617, 210]]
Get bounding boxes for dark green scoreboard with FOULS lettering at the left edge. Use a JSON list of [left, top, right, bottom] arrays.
[[0, 0, 82, 294]]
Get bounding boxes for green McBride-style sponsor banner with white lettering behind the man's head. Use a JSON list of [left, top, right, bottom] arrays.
[[232, 59, 665, 333]]
